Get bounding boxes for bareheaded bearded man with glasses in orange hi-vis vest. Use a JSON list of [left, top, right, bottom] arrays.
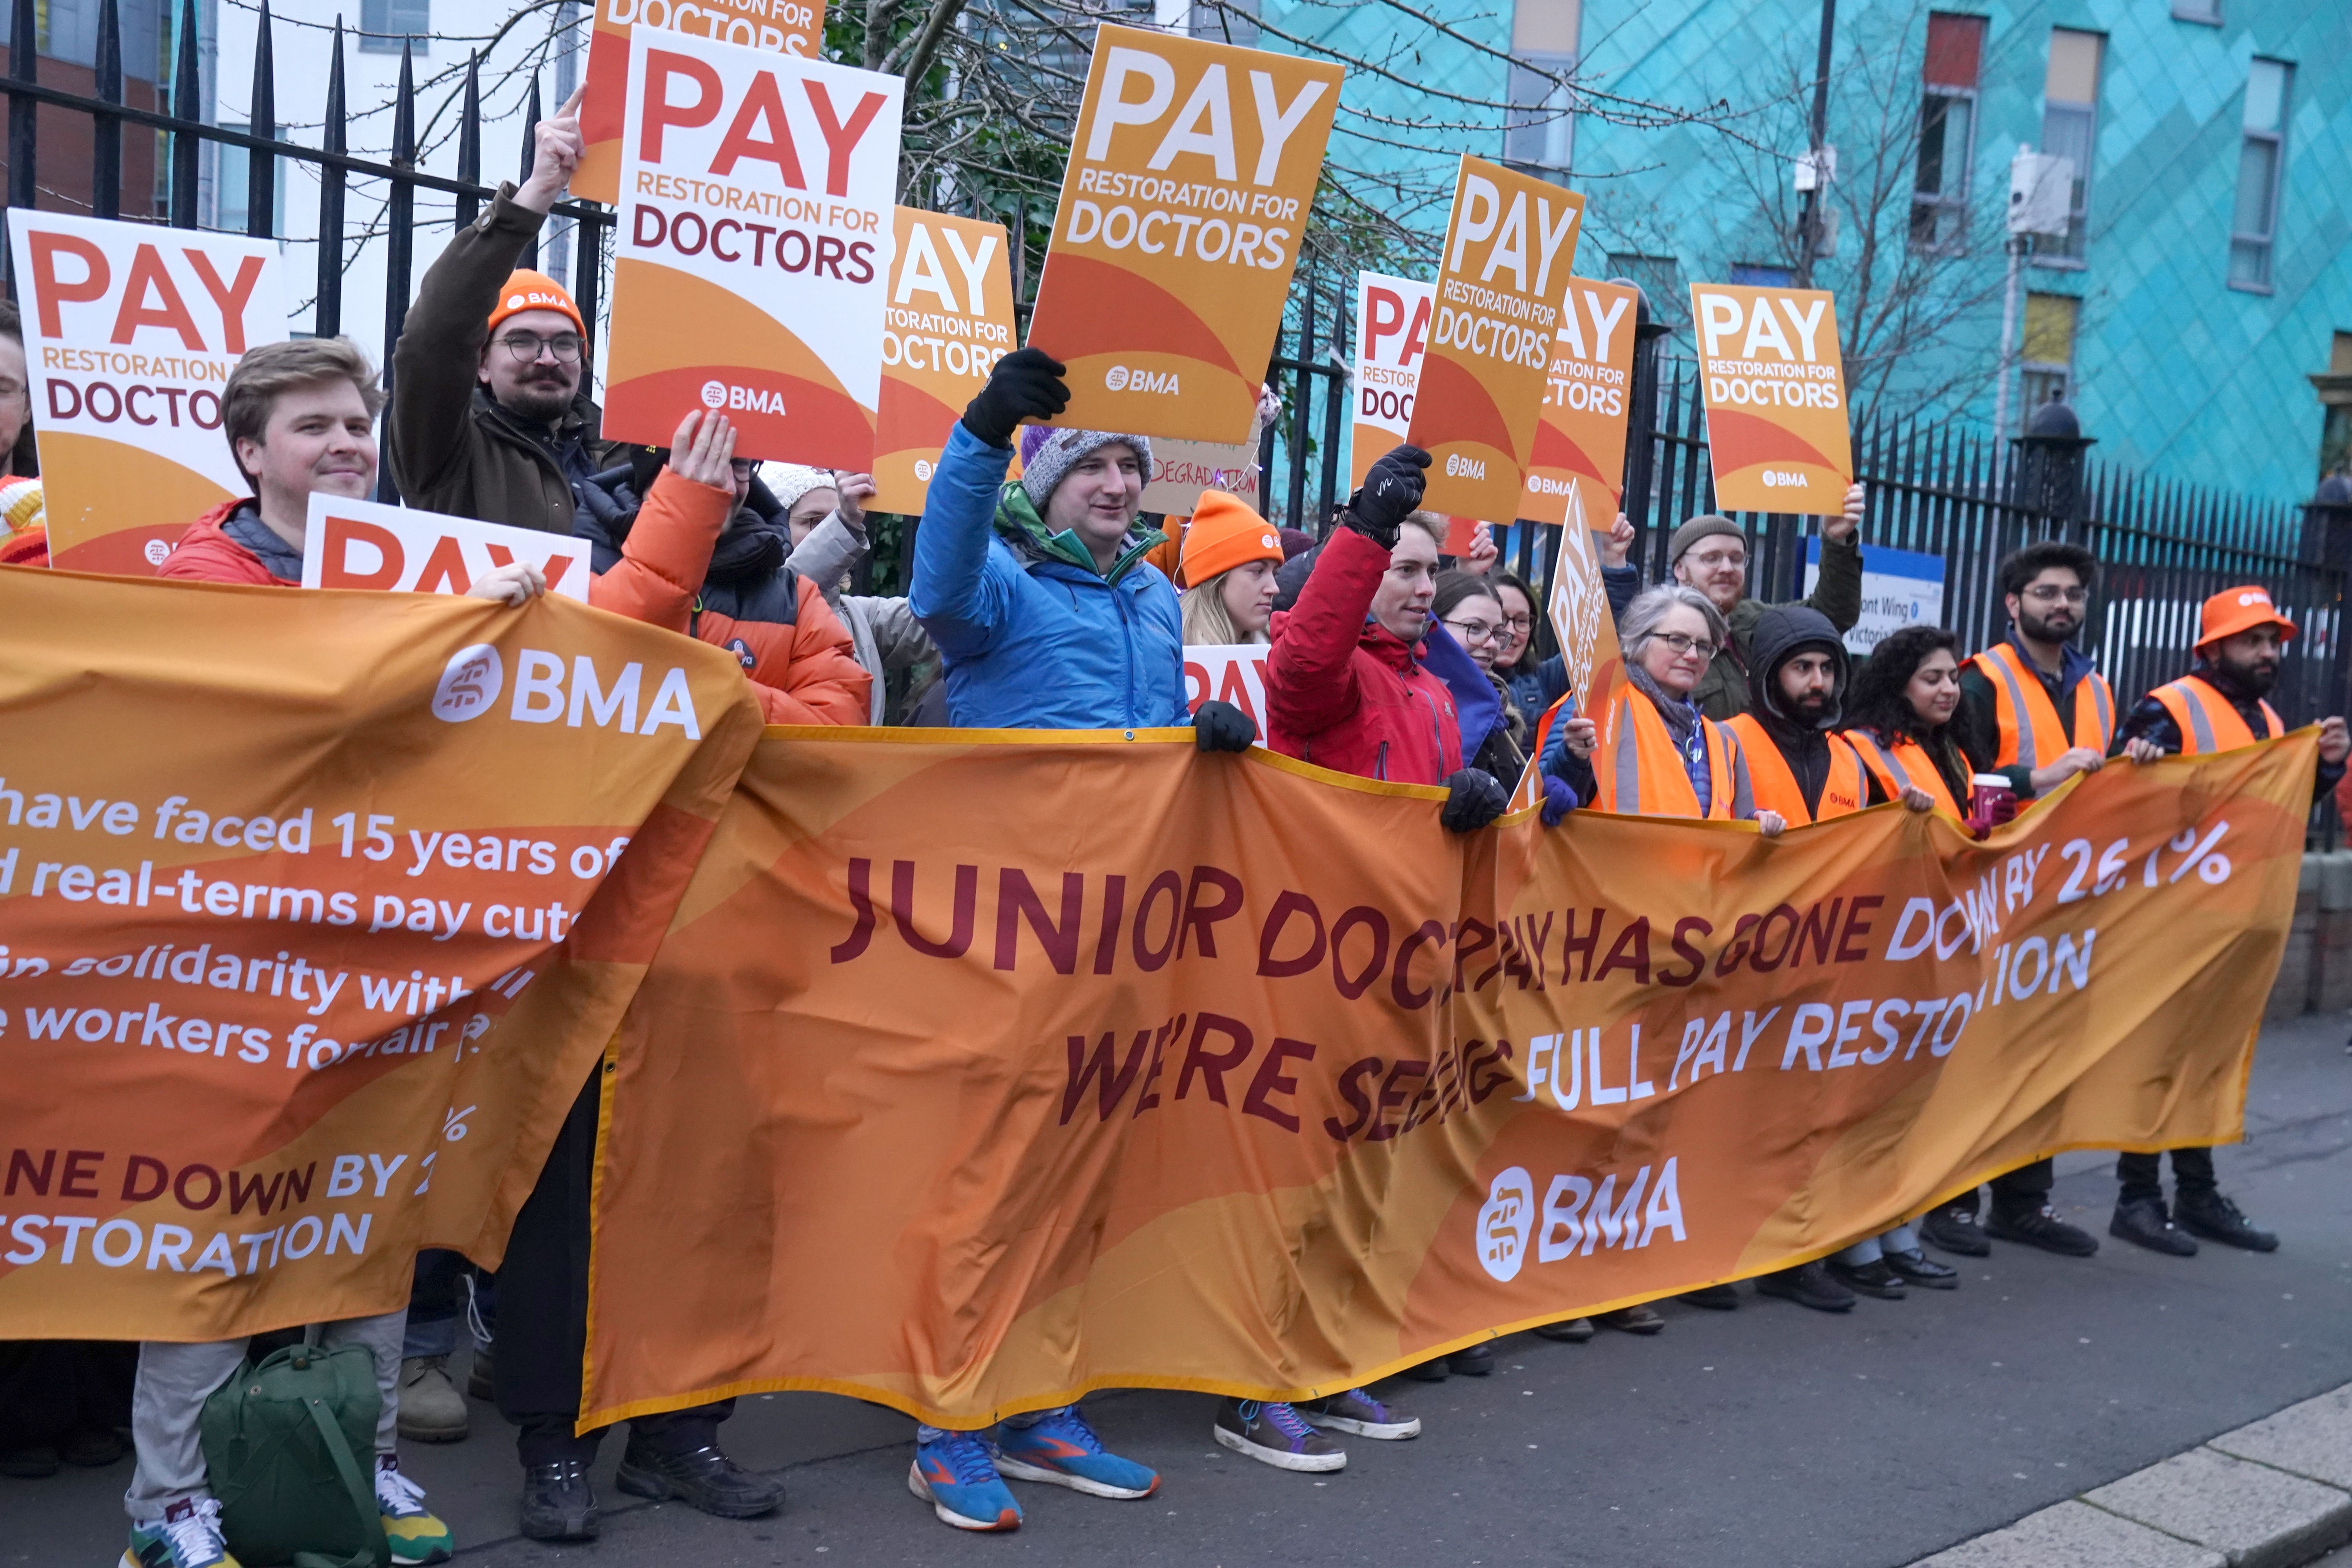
[[1919, 538, 2114, 1258]]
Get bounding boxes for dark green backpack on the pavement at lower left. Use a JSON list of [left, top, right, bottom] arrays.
[[202, 1345, 393, 1568]]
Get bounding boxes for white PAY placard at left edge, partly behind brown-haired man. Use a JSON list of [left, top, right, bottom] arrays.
[[9, 207, 287, 576]]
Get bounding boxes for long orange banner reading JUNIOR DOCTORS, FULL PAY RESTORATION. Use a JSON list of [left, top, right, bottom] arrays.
[[583, 729, 2314, 1427]]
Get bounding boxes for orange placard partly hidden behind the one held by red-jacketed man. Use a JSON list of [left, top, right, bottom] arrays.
[[1519, 278, 1642, 522]]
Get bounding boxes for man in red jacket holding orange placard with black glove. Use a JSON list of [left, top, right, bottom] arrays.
[[1265, 446, 1510, 832]]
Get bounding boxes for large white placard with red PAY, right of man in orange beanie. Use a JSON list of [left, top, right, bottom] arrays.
[[604, 28, 901, 472]]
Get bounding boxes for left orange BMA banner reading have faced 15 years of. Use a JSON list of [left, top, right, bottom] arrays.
[[0, 566, 760, 1340]]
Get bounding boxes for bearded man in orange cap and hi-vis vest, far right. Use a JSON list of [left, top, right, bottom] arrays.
[[2107, 585, 2352, 1258]]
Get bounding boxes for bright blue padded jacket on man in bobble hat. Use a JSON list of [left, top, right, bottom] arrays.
[[908, 421, 1192, 729]]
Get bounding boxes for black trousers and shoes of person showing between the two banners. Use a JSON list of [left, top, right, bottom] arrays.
[[492, 1065, 734, 1467]]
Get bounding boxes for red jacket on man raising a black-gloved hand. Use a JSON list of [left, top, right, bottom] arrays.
[[1265, 529, 1463, 785]]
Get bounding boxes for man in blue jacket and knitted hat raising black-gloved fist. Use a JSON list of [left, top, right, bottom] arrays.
[[908, 348, 1256, 1530]]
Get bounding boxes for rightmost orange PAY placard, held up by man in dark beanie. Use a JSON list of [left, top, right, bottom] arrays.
[[1691, 282, 1853, 517]]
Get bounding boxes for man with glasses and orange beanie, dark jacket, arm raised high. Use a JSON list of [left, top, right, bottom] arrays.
[[386, 94, 626, 534]]
